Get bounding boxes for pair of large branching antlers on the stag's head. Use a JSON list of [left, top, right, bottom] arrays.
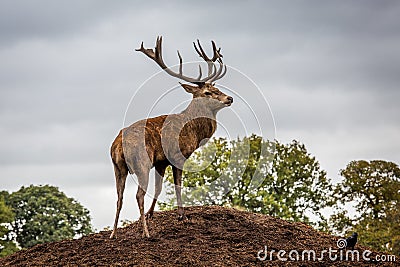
[[136, 36, 226, 85]]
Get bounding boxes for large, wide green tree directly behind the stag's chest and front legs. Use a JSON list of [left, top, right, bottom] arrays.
[[160, 135, 332, 226]]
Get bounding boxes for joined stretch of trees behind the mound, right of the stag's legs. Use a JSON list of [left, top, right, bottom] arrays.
[[159, 135, 400, 255]]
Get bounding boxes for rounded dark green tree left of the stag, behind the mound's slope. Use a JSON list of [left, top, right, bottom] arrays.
[[6, 185, 92, 248]]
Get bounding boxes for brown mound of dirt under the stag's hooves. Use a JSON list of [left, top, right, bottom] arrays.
[[0, 207, 399, 266]]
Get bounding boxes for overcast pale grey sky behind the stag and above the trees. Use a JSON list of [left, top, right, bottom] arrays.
[[0, 0, 400, 229]]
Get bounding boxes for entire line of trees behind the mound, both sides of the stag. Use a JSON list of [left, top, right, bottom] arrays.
[[0, 135, 400, 257]]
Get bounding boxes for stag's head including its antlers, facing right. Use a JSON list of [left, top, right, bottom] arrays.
[[136, 36, 233, 112]]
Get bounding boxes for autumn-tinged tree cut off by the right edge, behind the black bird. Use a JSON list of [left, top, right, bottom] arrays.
[[330, 160, 400, 255]]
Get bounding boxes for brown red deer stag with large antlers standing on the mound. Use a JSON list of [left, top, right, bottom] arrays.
[[110, 37, 233, 238]]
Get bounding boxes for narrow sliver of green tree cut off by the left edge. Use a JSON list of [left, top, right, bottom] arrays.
[[0, 196, 18, 257]]
